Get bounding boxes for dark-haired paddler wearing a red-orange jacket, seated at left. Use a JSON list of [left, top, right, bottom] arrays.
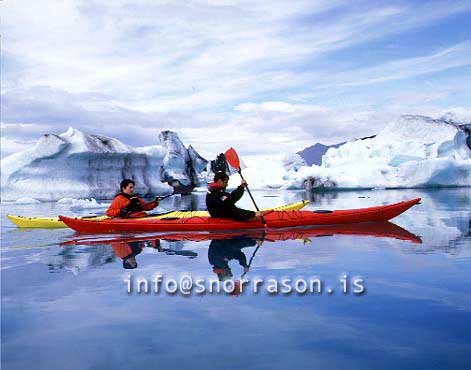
[[106, 179, 159, 218]]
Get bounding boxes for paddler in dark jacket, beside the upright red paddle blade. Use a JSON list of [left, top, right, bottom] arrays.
[[206, 172, 260, 221]]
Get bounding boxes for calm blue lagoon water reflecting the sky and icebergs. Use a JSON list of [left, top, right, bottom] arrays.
[[1, 189, 471, 369]]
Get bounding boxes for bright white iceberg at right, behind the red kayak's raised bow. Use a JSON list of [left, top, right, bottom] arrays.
[[240, 115, 471, 190]]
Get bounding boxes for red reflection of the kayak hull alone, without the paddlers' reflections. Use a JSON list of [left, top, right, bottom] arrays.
[[61, 222, 422, 246]]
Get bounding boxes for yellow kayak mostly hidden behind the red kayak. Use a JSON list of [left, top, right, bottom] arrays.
[[7, 200, 309, 229]]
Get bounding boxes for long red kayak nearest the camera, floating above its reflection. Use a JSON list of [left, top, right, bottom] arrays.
[[59, 198, 420, 233]]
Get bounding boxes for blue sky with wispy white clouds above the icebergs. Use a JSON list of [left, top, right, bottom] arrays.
[[0, 0, 471, 158]]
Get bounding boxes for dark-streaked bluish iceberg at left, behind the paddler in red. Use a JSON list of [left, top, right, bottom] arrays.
[[1, 128, 207, 201]]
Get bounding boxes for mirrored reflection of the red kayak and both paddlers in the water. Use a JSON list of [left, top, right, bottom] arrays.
[[62, 222, 422, 270]]
